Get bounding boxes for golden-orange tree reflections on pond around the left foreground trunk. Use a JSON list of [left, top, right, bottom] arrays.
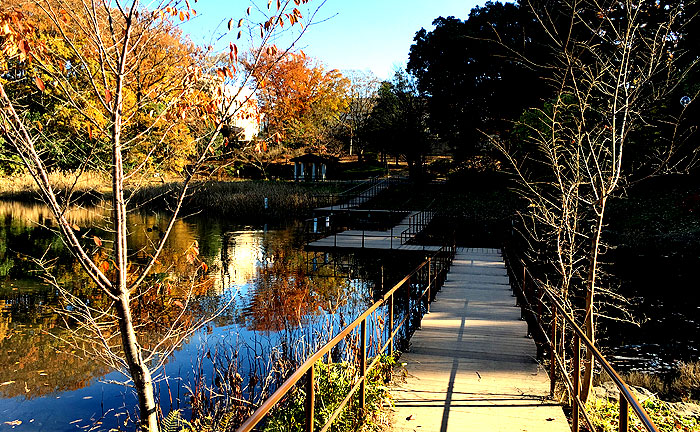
[[0, 203, 212, 398]]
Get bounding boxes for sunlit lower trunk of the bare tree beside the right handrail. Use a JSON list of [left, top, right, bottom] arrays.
[[581, 195, 607, 403]]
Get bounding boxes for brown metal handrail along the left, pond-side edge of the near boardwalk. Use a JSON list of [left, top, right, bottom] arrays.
[[236, 244, 456, 432]]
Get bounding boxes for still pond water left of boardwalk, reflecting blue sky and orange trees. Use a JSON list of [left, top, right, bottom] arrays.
[[0, 202, 382, 431]]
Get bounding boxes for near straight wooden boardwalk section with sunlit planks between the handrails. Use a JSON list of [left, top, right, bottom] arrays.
[[392, 249, 570, 432]]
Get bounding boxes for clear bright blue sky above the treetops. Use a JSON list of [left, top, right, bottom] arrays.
[[183, 0, 483, 79]]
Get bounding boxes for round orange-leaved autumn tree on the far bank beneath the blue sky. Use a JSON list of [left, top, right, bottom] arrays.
[[245, 49, 350, 151]]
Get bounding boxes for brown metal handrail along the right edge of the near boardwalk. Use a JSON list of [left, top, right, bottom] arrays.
[[504, 248, 658, 432]]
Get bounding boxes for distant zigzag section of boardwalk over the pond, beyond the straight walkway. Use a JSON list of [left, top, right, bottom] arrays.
[[306, 211, 440, 252]]
